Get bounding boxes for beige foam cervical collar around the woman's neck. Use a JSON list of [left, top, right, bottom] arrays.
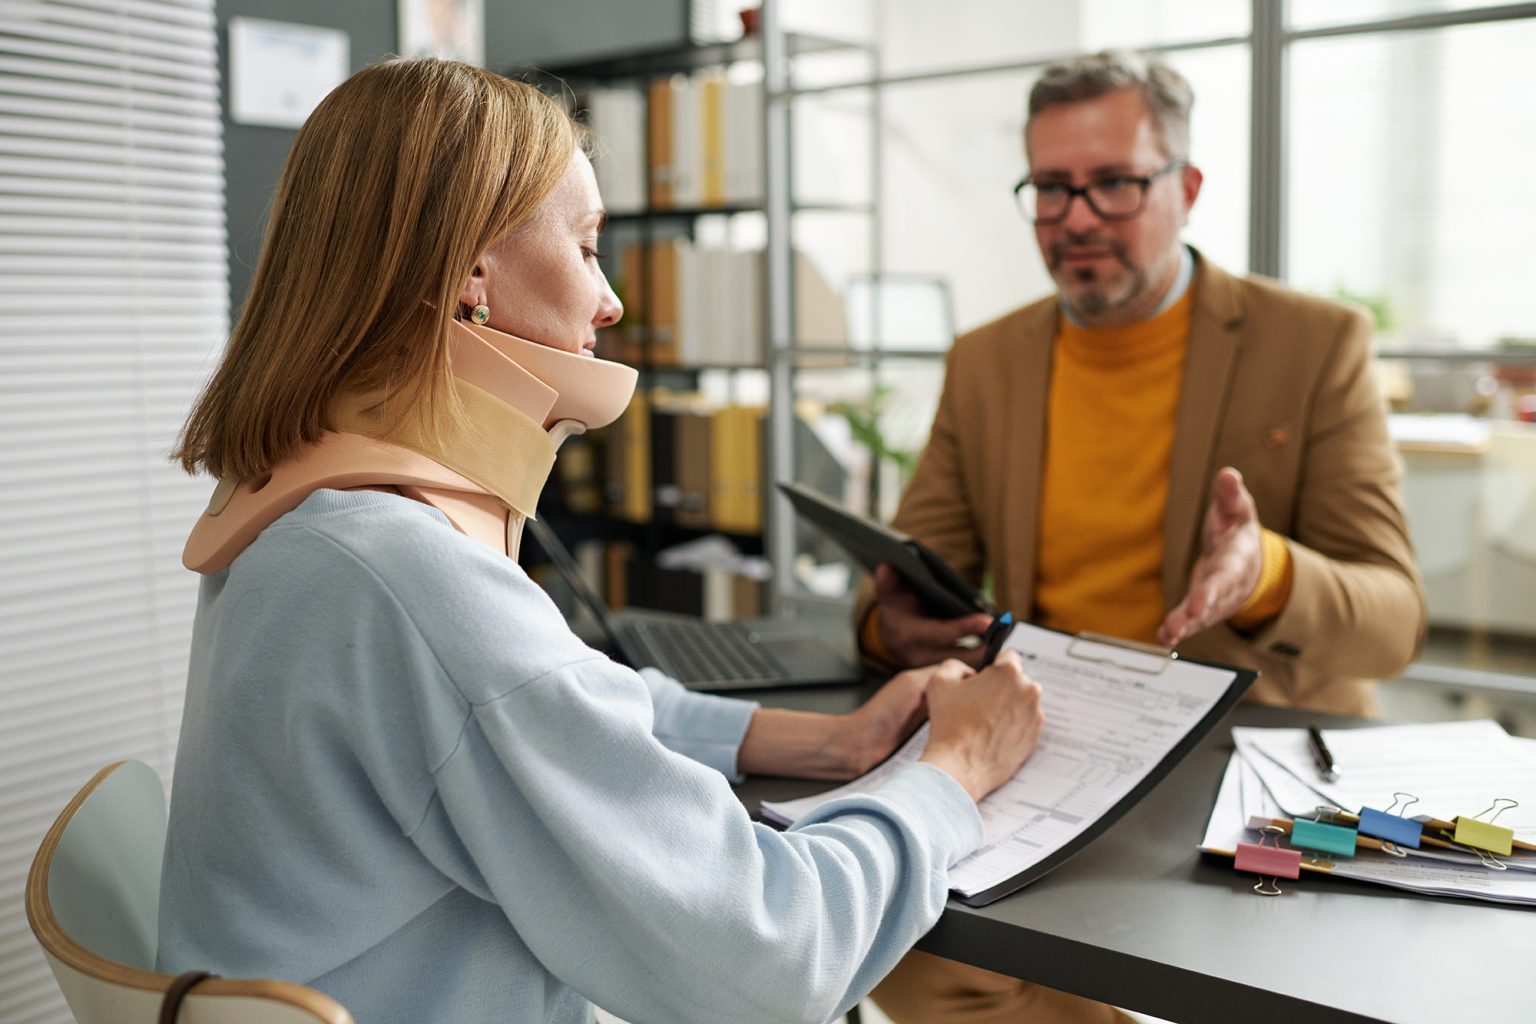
[[181, 322, 636, 573]]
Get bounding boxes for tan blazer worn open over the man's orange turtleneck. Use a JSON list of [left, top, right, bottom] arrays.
[[856, 259, 1425, 714]]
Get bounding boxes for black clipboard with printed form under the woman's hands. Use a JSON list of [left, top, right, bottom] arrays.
[[762, 623, 1258, 907]]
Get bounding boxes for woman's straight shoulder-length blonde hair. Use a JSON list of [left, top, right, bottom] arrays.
[[170, 58, 588, 481]]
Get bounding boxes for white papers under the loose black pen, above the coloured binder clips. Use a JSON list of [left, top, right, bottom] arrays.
[[1232, 720, 1536, 843]]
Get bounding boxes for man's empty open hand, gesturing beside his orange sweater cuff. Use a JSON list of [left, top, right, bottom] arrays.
[[1157, 467, 1264, 646]]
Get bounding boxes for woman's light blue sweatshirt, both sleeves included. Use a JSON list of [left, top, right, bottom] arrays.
[[158, 491, 982, 1024]]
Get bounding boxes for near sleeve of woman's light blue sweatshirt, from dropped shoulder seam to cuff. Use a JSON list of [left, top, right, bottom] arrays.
[[421, 659, 982, 1024]]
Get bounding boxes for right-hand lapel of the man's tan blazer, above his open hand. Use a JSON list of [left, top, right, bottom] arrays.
[[1163, 253, 1244, 608]]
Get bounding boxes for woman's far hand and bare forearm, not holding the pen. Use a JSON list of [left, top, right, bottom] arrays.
[[736, 660, 974, 780]]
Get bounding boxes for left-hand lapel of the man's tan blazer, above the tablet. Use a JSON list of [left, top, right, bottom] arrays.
[[989, 299, 1060, 620]]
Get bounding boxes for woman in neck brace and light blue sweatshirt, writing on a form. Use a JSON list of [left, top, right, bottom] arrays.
[[160, 60, 1040, 1024]]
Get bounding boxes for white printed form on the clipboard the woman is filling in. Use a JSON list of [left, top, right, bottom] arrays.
[[763, 625, 1233, 895]]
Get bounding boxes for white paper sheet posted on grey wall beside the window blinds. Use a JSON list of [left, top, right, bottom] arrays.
[[229, 18, 352, 127]]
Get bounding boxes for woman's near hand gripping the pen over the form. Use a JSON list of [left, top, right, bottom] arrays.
[[922, 651, 1044, 801]]
